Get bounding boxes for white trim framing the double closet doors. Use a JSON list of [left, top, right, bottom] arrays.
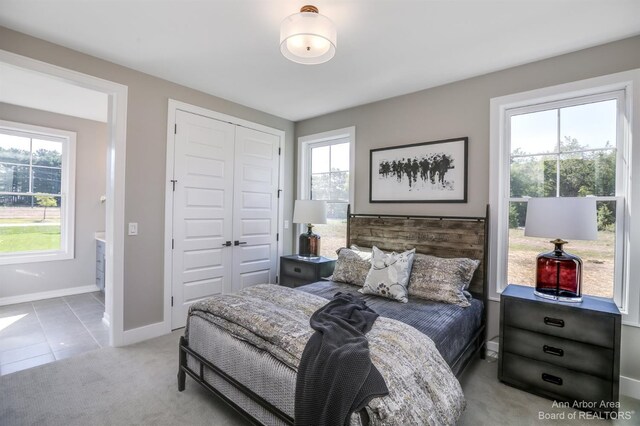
[[162, 99, 286, 333]]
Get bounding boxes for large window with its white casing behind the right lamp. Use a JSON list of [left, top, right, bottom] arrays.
[[490, 72, 632, 320]]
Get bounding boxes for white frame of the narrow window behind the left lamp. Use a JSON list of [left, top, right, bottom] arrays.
[[296, 126, 356, 251]]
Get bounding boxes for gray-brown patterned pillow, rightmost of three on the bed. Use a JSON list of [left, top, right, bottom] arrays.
[[409, 254, 480, 307]]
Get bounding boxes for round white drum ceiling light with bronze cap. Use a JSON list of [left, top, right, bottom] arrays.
[[280, 5, 336, 65]]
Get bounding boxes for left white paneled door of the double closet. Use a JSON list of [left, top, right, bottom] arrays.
[[171, 110, 235, 329]]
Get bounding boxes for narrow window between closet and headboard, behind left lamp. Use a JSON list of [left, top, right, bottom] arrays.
[[300, 128, 355, 259]]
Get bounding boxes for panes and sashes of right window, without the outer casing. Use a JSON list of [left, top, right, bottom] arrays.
[[506, 92, 624, 298]]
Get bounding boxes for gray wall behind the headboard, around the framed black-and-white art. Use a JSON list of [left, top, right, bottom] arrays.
[[296, 37, 640, 379]]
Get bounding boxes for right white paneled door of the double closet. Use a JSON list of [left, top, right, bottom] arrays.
[[233, 126, 280, 291]]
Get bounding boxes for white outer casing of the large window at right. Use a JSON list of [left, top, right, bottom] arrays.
[[488, 69, 640, 326]]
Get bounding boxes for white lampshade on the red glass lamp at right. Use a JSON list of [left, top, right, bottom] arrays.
[[524, 197, 598, 240]]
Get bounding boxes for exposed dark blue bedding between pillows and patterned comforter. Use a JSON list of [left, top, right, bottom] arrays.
[[296, 281, 483, 366]]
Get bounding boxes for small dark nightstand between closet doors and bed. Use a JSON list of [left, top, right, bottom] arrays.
[[279, 254, 336, 287]]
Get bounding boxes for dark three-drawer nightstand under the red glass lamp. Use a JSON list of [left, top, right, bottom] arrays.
[[498, 284, 621, 412]]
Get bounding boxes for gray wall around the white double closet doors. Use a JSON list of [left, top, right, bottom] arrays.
[[0, 27, 295, 330]]
